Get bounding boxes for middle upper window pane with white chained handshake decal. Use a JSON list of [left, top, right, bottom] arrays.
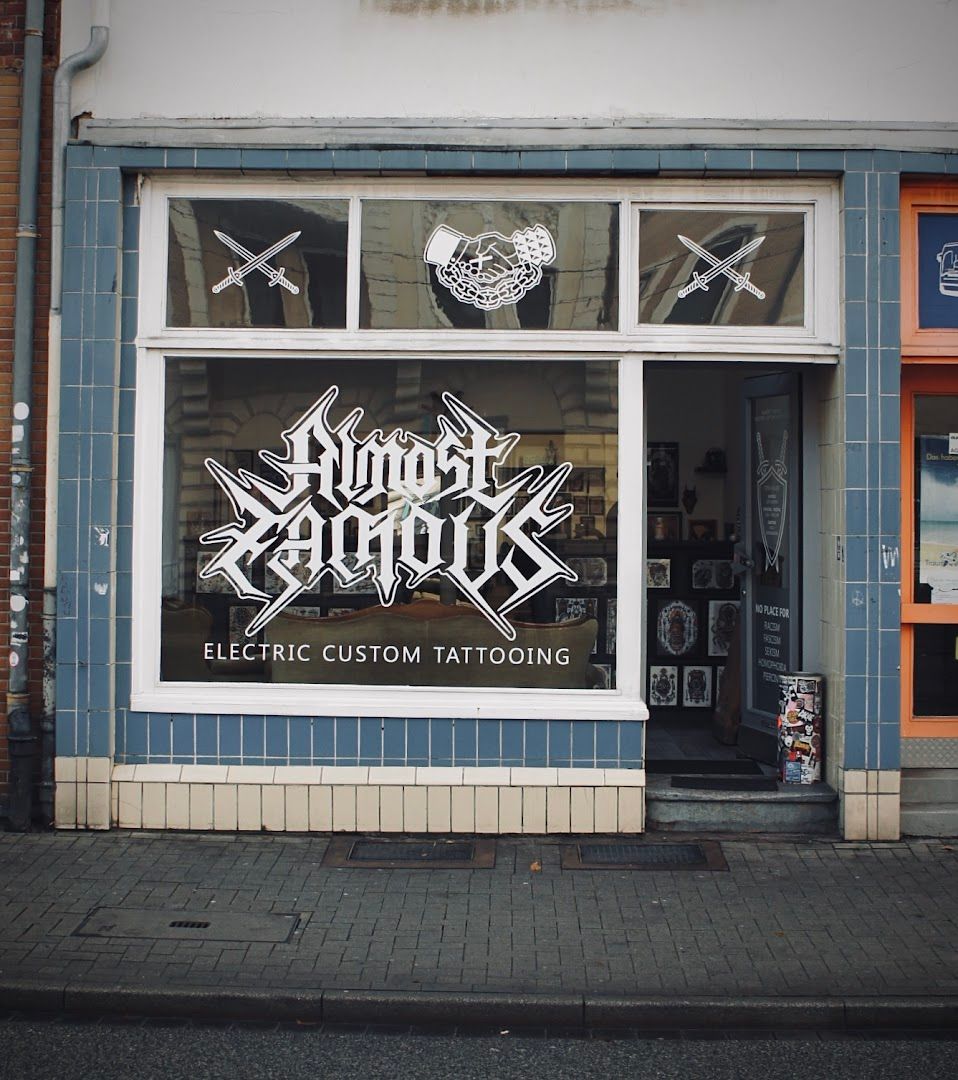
[[360, 199, 619, 330]]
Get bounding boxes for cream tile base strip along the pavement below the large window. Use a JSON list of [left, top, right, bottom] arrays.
[[75, 758, 645, 834]]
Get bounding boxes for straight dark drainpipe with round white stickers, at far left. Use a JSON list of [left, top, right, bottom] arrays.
[[6, 0, 43, 832]]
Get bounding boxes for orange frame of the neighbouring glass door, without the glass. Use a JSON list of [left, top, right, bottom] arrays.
[[901, 361, 958, 739]]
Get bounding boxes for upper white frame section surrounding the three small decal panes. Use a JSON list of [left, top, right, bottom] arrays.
[[137, 178, 840, 354]]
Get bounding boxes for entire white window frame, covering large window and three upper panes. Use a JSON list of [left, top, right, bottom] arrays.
[[131, 178, 839, 720]]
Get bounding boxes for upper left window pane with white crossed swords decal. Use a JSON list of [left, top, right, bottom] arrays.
[[166, 199, 349, 329]]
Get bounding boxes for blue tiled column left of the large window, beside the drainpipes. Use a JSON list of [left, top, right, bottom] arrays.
[[56, 146, 125, 757]]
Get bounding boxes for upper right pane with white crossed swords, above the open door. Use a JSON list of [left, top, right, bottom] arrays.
[[638, 207, 808, 327]]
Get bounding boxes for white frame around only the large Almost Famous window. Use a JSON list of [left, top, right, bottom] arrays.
[[131, 348, 647, 719]]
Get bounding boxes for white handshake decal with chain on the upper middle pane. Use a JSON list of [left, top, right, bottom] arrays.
[[423, 225, 555, 311]]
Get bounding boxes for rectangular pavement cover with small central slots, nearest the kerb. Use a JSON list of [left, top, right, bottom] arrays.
[[73, 907, 299, 942]]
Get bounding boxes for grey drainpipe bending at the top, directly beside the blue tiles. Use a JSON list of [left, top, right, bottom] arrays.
[[40, 0, 110, 824]]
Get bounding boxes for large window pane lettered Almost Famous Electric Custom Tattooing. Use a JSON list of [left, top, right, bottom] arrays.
[[158, 356, 619, 690]]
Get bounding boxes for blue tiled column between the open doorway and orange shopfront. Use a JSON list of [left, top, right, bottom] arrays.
[[842, 151, 901, 770]]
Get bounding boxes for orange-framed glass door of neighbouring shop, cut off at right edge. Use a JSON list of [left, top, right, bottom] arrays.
[[902, 365, 958, 738]]
